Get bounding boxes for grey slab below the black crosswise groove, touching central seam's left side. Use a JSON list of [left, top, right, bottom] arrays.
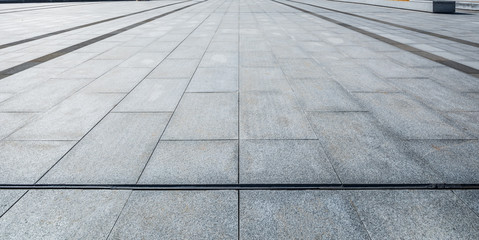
[[109, 191, 238, 239]]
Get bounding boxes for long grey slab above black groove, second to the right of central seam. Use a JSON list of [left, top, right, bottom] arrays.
[[309, 112, 438, 183]]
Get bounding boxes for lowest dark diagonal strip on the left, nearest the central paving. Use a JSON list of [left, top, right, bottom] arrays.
[[0, 1, 204, 80]]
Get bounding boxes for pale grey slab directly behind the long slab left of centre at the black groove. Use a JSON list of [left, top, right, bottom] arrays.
[[113, 78, 189, 112]]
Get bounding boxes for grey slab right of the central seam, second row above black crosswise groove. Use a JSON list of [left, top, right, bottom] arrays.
[[240, 91, 317, 139]]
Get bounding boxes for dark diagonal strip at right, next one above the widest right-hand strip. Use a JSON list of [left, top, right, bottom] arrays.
[[286, 0, 479, 48]]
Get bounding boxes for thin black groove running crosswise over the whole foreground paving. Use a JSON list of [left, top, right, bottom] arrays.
[[0, 183, 479, 191]]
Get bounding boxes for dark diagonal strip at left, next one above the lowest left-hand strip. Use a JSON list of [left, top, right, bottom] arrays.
[[0, 0, 191, 49]]
